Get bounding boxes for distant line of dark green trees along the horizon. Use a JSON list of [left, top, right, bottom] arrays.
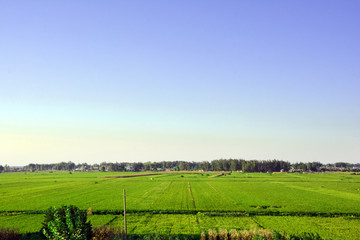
[[0, 159, 354, 172]]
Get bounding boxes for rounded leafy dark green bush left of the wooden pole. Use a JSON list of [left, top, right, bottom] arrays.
[[41, 205, 92, 240]]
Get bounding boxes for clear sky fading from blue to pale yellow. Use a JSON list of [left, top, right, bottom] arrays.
[[0, 0, 360, 166]]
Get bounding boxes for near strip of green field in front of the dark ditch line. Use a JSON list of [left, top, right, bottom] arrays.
[[0, 213, 360, 239]]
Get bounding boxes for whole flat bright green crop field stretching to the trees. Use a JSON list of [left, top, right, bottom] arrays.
[[0, 172, 360, 239]]
